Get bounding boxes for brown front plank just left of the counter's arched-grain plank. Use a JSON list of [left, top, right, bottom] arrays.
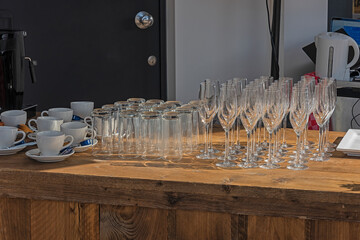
[[31, 200, 99, 239]]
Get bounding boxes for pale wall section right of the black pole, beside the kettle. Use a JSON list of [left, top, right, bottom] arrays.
[[283, 0, 328, 79]]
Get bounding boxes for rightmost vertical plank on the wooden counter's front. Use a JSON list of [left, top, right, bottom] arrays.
[[310, 220, 360, 240]]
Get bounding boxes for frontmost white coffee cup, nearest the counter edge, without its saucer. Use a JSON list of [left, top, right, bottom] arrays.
[[36, 131, 74, 156]]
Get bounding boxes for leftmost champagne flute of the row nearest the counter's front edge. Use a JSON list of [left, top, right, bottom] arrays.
[[216, 83, 238, 167]]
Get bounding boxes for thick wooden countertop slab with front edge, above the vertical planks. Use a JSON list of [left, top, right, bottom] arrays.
[[0, 130, 360, 221]]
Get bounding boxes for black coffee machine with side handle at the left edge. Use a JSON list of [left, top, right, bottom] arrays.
[[0, 29, 36, 112]]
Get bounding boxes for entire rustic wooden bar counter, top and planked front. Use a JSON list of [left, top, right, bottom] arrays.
[[0, 130, 360, 240]]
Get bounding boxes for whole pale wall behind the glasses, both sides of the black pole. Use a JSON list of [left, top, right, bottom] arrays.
[[167, 0, 327, 102]]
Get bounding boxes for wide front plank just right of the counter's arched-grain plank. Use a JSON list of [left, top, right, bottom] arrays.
[[176, 210, 231, 240]]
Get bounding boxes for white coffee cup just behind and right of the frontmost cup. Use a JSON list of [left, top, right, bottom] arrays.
[[60, 122, 93, 144]]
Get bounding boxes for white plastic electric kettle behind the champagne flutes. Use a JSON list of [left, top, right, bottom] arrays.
[[315, 32, 359, 81]]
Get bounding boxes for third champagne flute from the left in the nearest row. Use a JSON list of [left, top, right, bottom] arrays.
[[260, 88, 283, 169]]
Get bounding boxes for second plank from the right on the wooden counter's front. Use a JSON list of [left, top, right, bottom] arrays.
[[248, 216, 306, 240]]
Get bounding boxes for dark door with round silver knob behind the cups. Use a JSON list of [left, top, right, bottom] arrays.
[[0, 0, 166, 110]]
